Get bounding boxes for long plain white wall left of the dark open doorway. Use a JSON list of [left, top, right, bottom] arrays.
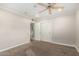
[[0, 10, 30, 50]]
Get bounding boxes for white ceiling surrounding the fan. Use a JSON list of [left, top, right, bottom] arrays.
[[0, 3, 79, 19]]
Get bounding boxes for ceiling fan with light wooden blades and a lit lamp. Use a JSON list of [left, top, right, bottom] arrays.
[[38, 3, 64, 14]]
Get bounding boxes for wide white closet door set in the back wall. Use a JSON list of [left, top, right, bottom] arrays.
[[40, 22, 54, 42]]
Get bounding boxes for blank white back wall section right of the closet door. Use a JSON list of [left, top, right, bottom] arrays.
[[53, 16, 75, 45]]
